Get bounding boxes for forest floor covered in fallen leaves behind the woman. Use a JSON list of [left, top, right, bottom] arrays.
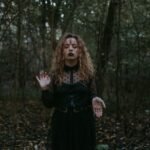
[[0, 101, 150, 150]]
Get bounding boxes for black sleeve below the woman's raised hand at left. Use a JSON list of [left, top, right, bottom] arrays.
[[41, 73, 55, 108]]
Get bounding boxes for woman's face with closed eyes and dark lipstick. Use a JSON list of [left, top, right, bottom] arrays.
[[63, 37, 79, 60]]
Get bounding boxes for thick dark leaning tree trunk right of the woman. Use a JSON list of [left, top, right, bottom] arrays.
[[96, 0, 118, 95]]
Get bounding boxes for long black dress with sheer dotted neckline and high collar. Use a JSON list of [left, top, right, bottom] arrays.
[[42, 65, 96, 150]]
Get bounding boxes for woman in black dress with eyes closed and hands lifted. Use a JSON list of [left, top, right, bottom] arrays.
[[36, 34, 105, 150]]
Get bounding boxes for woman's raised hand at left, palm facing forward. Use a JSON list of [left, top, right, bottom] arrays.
[[36, 71, 51, 90]]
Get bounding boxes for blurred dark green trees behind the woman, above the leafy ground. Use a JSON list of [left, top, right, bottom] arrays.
[[0, 0, 150, 149]]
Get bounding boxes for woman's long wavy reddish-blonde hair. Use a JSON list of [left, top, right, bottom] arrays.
[[51, 33, 94, 84]]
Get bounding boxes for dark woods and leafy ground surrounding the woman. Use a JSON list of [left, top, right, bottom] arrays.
[[0, 0, 150, 150]]
